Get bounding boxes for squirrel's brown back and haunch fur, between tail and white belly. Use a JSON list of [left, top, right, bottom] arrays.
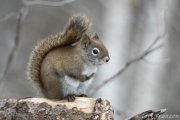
[[41, 46, 83, 99]]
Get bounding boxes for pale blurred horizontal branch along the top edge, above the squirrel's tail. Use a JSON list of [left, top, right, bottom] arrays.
[[23, 0, 75, 7]]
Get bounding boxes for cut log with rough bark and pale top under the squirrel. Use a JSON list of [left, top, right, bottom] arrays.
[[0, 97, 113, 120]]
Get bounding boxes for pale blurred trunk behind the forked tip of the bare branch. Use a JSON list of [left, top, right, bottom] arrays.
[[125, 0, 165, 112]]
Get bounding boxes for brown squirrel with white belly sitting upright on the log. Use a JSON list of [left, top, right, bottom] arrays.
[[27, 15, 110, 102]]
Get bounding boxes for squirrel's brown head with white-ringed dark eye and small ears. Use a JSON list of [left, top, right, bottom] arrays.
[[80, 34, 110, 65]]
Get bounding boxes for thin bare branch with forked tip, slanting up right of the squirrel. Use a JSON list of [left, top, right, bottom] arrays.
[[89, 34, 165, 95]]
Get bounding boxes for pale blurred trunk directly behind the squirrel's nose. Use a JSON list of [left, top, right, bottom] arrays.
[[95, 0, 134, 120]]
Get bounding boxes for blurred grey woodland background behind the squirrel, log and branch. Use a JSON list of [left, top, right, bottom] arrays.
[[0, 0, 180, 120]]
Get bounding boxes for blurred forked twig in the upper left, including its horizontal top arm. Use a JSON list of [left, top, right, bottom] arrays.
[[0, 0, 76, 80]]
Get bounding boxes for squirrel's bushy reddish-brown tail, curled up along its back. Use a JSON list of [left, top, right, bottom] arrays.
[[27, 15, 91, 88]]
